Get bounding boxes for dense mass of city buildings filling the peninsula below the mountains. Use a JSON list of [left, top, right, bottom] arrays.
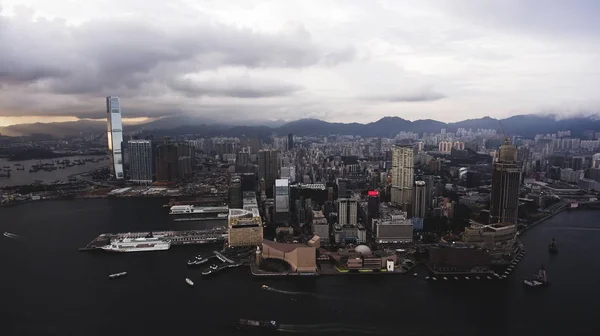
[[107, 97, 600, 276]]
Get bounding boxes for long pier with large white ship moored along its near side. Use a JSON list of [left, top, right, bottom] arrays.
[[79, 226, 227, 251]]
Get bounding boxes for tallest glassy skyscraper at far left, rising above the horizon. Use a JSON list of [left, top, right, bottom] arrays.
[[106, 97, 125, 180]]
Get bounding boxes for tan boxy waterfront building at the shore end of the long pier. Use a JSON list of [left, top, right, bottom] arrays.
[[227, 208, 263, 247]]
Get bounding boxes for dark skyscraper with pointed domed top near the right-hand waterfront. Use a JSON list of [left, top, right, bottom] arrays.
[[490, 138, 521, 224]]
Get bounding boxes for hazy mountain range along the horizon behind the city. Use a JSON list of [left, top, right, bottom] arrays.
[[0, 114, 600, 138]]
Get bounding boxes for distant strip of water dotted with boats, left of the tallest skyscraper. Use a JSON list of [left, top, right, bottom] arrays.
[[0, 155, 108, 187]]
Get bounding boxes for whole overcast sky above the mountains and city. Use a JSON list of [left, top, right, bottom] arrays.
[[0, 0, 600, 126]]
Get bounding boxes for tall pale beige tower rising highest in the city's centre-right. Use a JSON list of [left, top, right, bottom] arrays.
[[391, 145, 414, 204]]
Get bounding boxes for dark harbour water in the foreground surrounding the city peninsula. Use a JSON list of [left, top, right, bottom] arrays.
[[0, 199, 600, 336]]
